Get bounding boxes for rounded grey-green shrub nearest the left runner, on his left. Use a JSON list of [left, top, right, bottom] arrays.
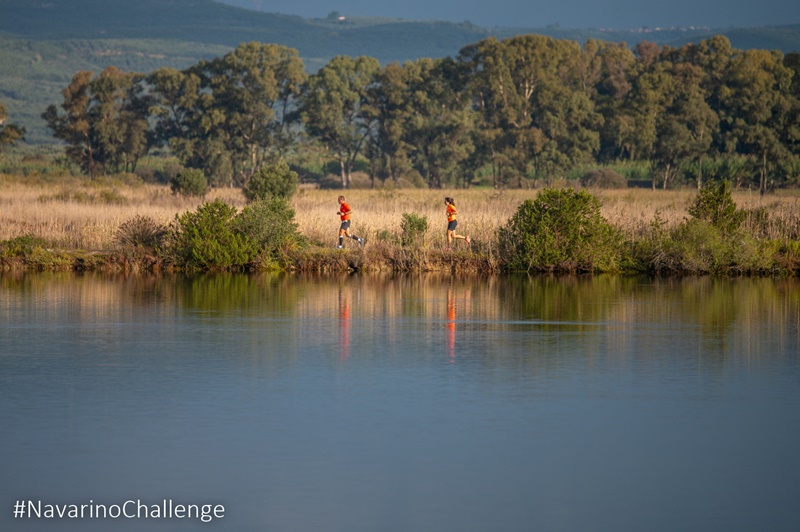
[[234, 197, 305, 259]]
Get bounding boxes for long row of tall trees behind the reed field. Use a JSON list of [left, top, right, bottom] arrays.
[[31, 35, 800, 193]]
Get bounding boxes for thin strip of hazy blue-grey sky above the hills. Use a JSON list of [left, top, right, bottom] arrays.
[[217, 0, 800, 29]]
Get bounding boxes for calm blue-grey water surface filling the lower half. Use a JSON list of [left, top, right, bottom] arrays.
[[0, 274, 800, 532]]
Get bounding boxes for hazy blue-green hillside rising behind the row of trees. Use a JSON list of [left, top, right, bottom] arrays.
[[0, 0, 800, 143]]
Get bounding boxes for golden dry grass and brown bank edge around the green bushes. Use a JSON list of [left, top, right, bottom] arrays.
[[0, 175, 800, 274]]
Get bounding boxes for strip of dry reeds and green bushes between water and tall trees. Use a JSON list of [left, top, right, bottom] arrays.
[[0, 175, 800, 275]]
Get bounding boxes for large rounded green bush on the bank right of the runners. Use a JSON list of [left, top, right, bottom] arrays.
[[500, 188, 622, 271]]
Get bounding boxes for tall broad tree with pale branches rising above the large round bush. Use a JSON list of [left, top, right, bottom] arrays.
[[460, 35, 602, 184]]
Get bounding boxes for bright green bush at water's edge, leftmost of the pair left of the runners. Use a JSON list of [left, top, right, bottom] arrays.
[[164, 199, 258, 270]]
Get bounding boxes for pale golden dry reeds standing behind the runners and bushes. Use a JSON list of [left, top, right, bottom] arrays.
[[0, 175, 800, 250]]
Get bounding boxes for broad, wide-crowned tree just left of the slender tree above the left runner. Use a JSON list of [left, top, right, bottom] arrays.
[[149, 42, 306, 185]]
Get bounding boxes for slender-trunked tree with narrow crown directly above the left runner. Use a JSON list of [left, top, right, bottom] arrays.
[[300, 56, 380, 188]]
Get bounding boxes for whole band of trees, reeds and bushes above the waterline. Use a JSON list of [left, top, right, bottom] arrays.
[[0, 30, 800, 274]]
